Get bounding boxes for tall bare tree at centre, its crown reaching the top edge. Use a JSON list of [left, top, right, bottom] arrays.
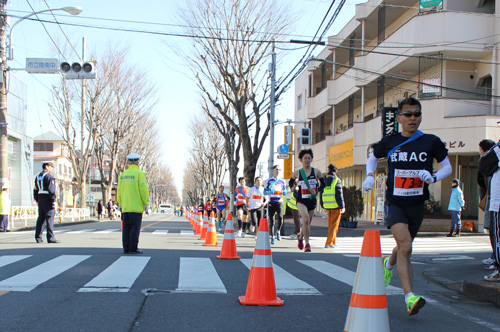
[[179, 0, 291, 184]]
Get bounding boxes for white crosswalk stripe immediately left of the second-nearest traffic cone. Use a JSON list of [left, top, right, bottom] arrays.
[[176, 257, 227, 293]]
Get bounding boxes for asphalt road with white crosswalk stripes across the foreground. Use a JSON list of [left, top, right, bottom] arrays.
[[0, 214, 500, 332]]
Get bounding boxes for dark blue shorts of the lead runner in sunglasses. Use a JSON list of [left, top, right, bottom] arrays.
[[385, 203, 424, 240]]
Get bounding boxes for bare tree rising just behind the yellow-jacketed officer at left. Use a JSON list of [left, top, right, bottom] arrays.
[[95, 47, 157, 202]]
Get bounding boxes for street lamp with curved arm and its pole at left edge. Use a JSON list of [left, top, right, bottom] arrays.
[[0, 5, 82, 183]]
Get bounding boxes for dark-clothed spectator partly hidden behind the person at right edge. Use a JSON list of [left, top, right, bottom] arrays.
[[477, 139, 495, 270]]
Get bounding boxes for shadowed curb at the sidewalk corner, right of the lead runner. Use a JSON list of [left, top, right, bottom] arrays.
[[422, 269, 500, 307]]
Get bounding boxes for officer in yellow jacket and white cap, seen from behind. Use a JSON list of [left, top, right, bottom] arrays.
[[116, 153, 151, 254]]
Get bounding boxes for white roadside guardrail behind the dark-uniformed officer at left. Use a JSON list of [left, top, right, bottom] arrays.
[[10, 206, 90, 229]]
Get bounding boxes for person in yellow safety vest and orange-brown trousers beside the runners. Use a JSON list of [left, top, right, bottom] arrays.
[[320, 164, 344, 248]]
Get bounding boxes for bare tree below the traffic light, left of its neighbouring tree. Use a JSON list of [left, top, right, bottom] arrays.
[[49, 60, 113, 208]]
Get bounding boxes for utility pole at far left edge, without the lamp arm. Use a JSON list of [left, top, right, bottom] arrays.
[[0, 0, 9, 183]]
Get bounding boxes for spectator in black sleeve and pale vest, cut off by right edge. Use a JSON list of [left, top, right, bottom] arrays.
[[478, 142, 500, 282]]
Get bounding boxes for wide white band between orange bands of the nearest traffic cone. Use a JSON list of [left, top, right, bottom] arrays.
[[352, 256, 386, 296]]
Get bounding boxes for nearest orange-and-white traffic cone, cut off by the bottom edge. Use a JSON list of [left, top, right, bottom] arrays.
[[344, 231, 390, 332]]
